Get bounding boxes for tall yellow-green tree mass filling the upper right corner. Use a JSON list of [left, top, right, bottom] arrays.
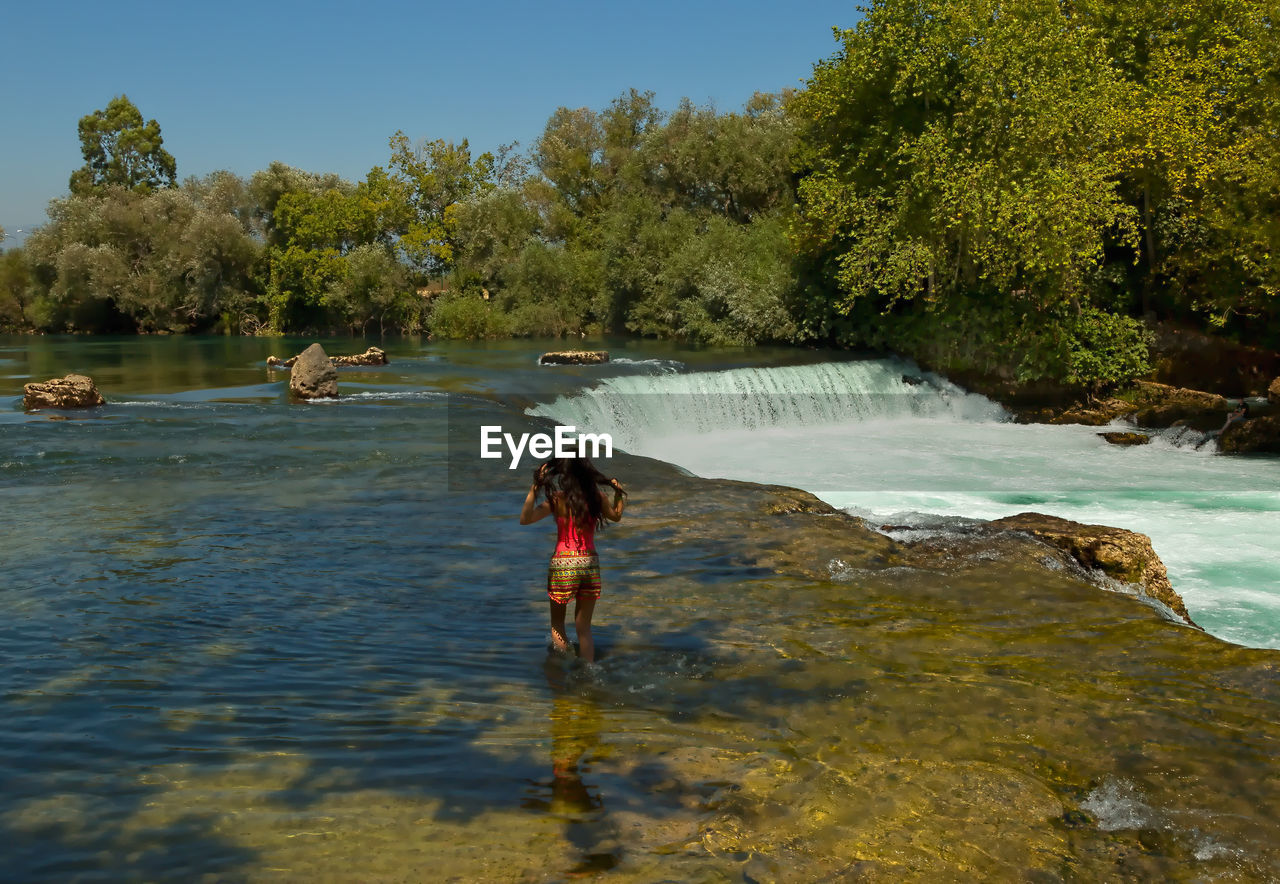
[[790, 0, 1280, 386]]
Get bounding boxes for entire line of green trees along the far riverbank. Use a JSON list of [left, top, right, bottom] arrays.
[[0, 0, 1280, 386]]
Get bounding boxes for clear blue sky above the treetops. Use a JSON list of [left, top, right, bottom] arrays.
[[0, 0, 858, 239]]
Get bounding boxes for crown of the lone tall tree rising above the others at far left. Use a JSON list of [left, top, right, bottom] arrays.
[[70, 95, 177, 196]]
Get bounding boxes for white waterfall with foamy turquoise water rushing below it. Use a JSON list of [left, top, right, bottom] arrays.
[[535, 361, 1280, 647]]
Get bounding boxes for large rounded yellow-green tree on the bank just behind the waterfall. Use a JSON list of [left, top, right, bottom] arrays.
[[791, 0, 1144, 383]]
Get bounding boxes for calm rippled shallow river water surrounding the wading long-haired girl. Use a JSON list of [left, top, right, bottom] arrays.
[[0, 340, 1280, 880]]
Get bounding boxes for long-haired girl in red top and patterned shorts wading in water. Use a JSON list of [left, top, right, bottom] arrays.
[[520, 457, 627, 663]]
